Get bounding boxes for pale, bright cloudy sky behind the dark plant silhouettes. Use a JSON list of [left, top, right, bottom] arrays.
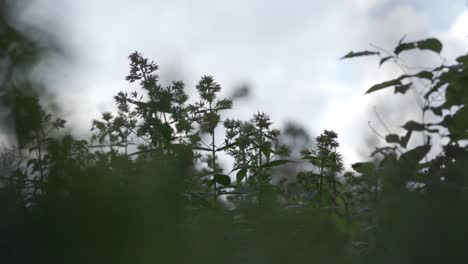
[[12, 0, 468, 164]]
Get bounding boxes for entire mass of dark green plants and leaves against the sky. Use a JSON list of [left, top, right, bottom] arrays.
[[0, 1, 468, 263]]
